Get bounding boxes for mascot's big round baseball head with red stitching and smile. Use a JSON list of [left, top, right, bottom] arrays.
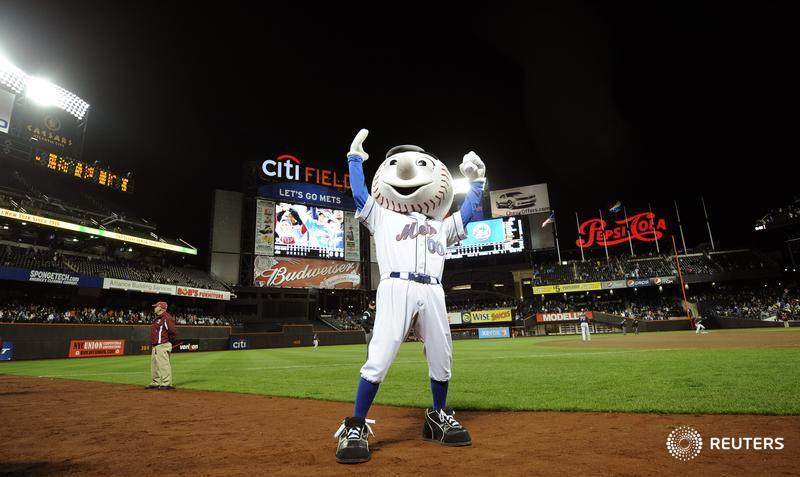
[[372, 146, 453, 220]]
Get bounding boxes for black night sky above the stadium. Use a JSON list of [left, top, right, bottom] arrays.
[[0, 1, 800, 260]]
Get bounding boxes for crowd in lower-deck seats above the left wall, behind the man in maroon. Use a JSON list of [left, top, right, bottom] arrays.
[[0, 301, 239, 326]]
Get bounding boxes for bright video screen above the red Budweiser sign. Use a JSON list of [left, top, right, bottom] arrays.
[[275, 202, 344, 260]]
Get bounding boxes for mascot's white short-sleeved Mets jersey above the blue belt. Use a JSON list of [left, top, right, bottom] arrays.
[[356, 196, 467, 281]]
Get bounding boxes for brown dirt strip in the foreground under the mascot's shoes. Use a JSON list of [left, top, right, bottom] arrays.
[[0, 376, 800, 476]]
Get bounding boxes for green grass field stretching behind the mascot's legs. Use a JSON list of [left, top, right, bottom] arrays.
[[0, 328, 800, 415]]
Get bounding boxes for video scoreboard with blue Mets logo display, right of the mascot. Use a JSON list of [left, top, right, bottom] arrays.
[[445, 217, 525, 258]]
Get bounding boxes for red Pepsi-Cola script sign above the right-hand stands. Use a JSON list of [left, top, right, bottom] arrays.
[[575, 212, 667, 248]]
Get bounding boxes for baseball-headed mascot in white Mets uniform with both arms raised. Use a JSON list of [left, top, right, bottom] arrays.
[[335, 129, 486, 464]]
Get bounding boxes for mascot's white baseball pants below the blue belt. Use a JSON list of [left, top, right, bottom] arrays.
[[361, 278, 453, 383]]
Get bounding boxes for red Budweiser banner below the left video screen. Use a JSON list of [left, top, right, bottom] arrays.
[[253, 256, 361, 288]]
